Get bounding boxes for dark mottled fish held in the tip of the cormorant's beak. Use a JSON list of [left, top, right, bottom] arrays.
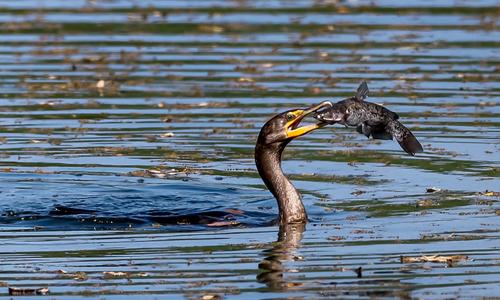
[[315, 81, 423, 156]]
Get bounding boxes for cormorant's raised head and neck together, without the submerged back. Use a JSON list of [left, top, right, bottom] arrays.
[[255, 101, 331, 225]]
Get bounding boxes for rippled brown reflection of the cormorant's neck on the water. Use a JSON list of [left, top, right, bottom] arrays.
[[257, 223, 306, 291]]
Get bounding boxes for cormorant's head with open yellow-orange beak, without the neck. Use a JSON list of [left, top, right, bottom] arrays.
[[257, 101, 332, 145]]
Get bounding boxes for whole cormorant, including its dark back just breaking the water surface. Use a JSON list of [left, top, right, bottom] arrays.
[[50, 101, 332, 226]]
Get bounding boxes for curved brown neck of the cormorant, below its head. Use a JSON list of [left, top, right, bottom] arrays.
[[255, 146, 307, 224]]
